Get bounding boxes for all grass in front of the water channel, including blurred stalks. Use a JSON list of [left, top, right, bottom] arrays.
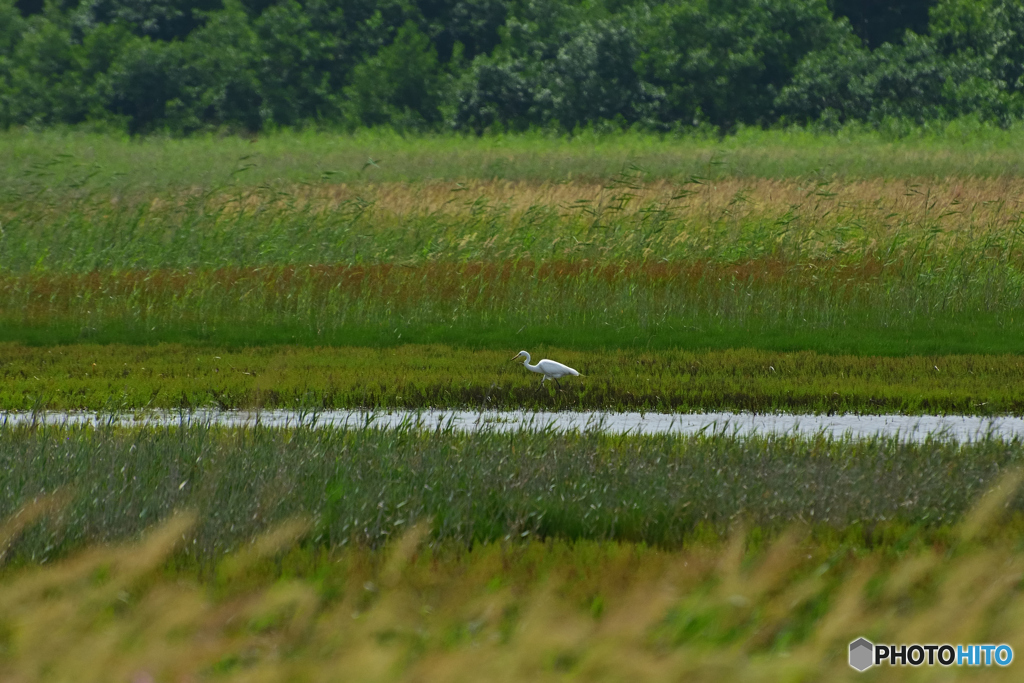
[[6, 426, 1024, 681]]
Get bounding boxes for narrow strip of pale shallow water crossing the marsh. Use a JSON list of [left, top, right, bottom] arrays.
[[0, 411, 1024, 441]]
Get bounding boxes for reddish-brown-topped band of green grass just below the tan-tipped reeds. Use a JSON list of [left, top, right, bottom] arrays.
[[0, 259, 1024, 355]]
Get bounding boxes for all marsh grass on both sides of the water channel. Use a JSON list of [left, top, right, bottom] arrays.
[[6, 130, 1024, 680]]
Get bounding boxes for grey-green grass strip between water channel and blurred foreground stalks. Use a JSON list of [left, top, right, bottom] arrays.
[[0, 425, 1024, 566]]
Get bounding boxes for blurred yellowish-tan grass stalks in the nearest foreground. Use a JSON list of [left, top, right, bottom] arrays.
[[0, 473, 1024, 683]]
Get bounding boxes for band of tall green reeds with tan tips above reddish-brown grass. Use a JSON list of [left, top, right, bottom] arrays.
[[0, 178, 1024, 275]]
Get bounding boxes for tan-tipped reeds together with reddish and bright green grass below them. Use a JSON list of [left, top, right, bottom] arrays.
[[6, 178, 1024, 355]]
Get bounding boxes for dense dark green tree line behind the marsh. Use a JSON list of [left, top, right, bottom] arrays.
[[0, 0, 1024, 133]]
